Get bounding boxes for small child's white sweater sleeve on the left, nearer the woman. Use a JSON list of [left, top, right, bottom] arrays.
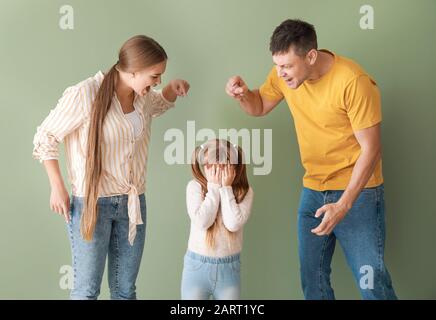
[[186, 180, 220, 230]]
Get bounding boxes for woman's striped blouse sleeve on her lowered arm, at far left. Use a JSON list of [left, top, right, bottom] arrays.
[[33, 87, 86, 162]]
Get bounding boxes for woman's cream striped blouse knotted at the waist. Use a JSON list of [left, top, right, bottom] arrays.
[[33, 71, 174, 244]]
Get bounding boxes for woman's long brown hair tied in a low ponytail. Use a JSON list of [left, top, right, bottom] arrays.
[[80, 35, 167, 240]]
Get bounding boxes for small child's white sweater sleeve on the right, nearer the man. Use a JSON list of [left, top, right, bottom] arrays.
[[219, 186, 254, 232]]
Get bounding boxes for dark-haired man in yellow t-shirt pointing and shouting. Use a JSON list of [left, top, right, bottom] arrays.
[[226, 20, 396, 299]]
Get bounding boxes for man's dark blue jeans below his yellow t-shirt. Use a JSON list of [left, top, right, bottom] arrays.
[[298, 185, 397, 300]]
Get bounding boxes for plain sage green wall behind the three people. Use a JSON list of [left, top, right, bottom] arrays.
[[0, 0, 436, 299]]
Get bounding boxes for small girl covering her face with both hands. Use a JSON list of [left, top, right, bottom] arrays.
[[182, 140, 253, 300]]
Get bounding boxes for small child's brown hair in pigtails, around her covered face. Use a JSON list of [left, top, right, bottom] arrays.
[[191, 139, 249, 248]]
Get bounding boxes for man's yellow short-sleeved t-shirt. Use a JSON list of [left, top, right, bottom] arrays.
[[259, 50, 383, 191]]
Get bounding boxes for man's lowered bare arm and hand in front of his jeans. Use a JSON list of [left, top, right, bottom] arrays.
[[312, 123, 381, 236]]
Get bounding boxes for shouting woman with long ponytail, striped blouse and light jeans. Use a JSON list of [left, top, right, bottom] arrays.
[[33, 36, 189, 299]]
